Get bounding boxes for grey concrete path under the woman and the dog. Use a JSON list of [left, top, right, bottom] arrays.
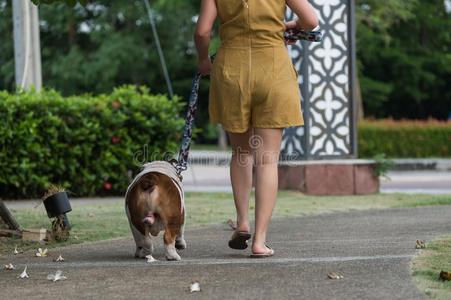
[[0, 206, 451, 299]]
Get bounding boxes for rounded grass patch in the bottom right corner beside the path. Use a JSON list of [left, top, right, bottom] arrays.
[[412, 236, 451, 299]]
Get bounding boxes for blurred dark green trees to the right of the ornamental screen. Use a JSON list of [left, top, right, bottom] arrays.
[[356, 0, 451, 120]]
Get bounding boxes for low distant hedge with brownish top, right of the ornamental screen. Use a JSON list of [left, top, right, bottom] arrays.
[[358, 120, 451, 158]]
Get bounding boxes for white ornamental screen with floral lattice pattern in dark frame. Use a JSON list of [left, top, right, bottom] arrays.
[[282, 0, 356, 160]]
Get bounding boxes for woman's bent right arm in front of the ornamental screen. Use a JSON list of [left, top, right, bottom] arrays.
[[286, 0, 319, 31]]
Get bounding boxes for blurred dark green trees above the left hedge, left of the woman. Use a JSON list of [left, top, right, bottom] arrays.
[[0, 0, 197, 96]]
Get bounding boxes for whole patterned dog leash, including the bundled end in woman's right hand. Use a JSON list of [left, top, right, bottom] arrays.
[[171, 30, 323, 180]]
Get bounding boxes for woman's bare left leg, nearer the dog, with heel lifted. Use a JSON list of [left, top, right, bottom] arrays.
[[228, 129, 253, 232]]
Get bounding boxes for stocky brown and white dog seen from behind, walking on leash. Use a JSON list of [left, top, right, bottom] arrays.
[[125, 161, 186, 260]]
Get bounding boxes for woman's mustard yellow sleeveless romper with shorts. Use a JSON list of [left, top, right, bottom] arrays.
[[209, 0, 304, 133]]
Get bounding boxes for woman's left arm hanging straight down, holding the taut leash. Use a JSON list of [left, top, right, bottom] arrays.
[[194, 0, 218, 75]]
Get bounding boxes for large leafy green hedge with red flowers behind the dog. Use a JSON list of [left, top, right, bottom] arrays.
[[0, 86, 184, 198]]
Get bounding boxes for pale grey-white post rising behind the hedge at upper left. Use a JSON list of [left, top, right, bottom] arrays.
[[13, 0, 42, 90]]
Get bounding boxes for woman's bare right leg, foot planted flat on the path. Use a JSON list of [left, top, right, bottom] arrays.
[[251, 128, 283, 253]]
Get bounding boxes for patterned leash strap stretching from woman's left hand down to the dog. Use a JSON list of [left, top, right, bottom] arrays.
[[175, 73, 202, 177]]
